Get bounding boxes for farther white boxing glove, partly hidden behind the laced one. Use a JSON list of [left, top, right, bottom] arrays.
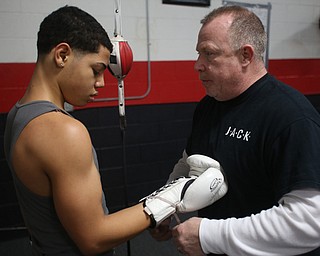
[[187, 154, 222, 177]]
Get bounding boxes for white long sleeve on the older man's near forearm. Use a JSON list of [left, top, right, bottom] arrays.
[[199, 190, 320, 256]]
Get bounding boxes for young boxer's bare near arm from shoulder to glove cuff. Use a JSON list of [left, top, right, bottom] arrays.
[[19, 113, 150, 254]]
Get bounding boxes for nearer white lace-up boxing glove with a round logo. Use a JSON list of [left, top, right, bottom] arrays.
[[140, 168, 227, 228]]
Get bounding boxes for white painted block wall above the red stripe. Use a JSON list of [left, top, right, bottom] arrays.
[[0, 0, 320, 63]]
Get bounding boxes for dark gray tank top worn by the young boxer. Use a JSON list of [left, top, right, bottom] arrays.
[[4, 101, 113, 256]]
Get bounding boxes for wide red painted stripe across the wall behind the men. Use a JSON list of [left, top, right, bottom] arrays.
[[0, 59, 320, 113]]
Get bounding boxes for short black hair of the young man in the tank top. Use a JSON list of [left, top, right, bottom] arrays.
[[37, 5, 113, 56]]
